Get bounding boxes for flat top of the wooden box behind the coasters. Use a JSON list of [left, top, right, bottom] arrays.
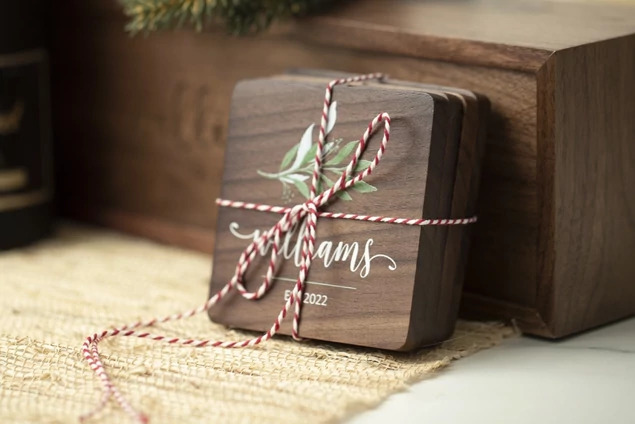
[[297, 0, 635, 57]]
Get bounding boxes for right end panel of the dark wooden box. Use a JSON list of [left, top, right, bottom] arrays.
[[552, 36, 635, 336]]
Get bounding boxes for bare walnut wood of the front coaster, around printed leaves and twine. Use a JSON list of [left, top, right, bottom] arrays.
[[211, 78, 462, 350]]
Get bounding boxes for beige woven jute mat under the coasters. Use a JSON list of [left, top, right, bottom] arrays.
[[0, 225, 512, 424]]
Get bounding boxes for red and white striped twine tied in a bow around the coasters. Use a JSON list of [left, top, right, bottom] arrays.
[[80, 74, 476, 423]]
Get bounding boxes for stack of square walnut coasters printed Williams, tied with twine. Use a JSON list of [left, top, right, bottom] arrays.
[[210, 71, 489, 350]]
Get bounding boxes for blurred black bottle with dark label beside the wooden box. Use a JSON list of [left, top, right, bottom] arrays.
[[0, 0, 53, 249]]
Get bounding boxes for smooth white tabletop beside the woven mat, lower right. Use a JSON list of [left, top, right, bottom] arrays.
[[349, 319, 635, 424]]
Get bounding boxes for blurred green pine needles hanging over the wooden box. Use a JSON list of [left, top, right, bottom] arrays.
[[119, 0, 330, 34]]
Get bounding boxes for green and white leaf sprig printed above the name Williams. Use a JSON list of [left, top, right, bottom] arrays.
[[257, 101, 377, 201]]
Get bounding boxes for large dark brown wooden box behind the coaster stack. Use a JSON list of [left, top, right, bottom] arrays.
[[53, 0, 635, 337]]
